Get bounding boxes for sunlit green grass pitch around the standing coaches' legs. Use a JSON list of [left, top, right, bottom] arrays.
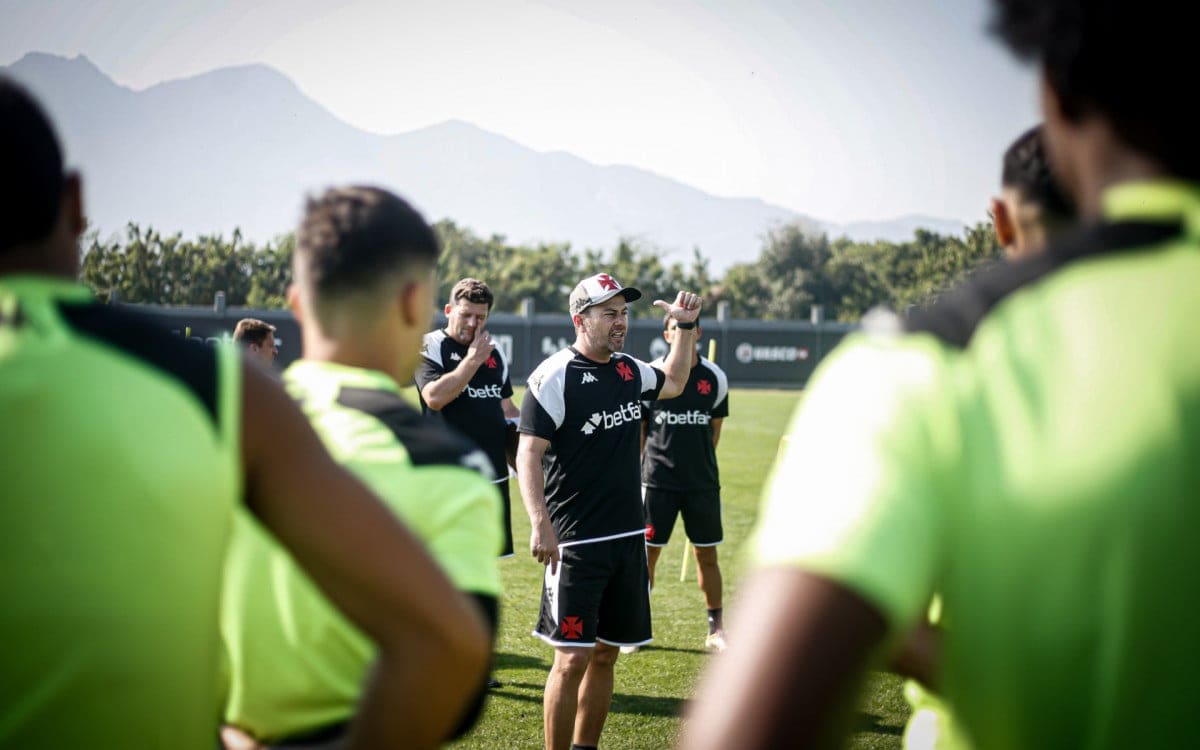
[[452, 390, 908, 750]]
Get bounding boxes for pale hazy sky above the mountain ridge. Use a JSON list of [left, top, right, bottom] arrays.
[[0, 0, 1037, 222]]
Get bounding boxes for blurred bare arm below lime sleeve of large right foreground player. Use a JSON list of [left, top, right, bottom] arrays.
[[679, 568, 886, 750]]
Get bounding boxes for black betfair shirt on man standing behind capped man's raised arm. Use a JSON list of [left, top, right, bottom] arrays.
[[642, 358, 730, 492]]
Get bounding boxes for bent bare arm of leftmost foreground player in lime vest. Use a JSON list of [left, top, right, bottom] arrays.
[[241, 367, 488, 748]]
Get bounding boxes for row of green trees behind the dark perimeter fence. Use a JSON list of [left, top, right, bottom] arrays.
[[83, 221, 1001, 322]]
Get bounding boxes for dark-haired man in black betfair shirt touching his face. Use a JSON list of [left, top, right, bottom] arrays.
[[416, 278, 521, 557]]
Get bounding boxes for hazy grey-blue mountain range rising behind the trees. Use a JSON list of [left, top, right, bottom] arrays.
[[0, 53, 962, 272]]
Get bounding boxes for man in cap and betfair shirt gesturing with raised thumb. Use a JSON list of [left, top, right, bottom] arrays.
[[517, 274, 700, 750]]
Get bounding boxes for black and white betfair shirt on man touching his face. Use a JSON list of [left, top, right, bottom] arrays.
[[414, 329, 512, 481]]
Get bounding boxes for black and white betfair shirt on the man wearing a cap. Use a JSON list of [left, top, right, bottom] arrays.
[[520, 347, 666, 546]]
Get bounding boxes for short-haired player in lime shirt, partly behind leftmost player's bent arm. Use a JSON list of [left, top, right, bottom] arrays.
[[222, 187, 502, 744]]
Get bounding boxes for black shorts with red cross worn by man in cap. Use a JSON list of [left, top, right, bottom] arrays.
[[533, 534, 650, 646]]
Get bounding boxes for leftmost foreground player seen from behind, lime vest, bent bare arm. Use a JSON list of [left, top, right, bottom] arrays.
[[0, 76, 487, 750]]
